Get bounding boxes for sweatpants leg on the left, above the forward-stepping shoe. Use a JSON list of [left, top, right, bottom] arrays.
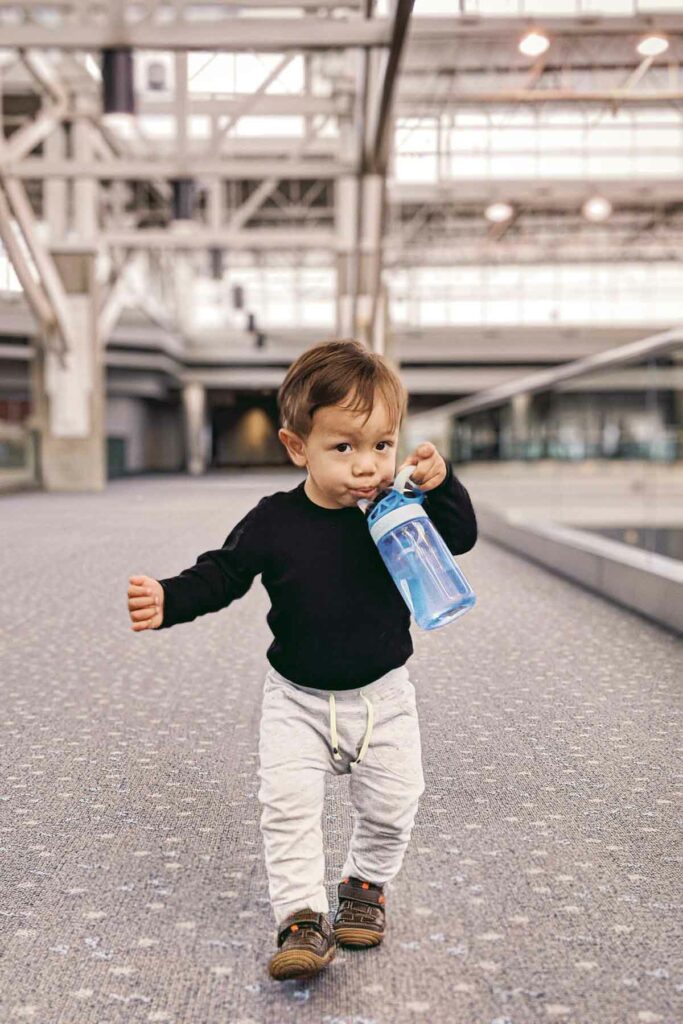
[[258, 677, 330, 924]]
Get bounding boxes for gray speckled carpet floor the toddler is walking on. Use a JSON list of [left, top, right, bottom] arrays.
[[0, 472, 683, 1024]]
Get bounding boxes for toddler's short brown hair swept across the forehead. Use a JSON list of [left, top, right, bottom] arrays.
[[278, 339, 408, 439]]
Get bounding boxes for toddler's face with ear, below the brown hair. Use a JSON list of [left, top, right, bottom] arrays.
[[280, 393, 398, 508]]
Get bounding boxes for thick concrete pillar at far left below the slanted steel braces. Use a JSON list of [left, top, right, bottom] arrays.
[[32, 248, 106, 490]]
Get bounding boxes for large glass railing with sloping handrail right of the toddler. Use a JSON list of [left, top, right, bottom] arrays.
[[402, 331, 683, 559]]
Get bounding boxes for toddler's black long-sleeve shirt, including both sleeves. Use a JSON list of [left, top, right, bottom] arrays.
[[160, 463, 477, 690]]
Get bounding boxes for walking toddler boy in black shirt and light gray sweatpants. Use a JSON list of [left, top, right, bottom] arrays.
[[128, 341, 477, 980]]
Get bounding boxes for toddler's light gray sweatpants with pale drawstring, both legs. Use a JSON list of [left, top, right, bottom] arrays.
[[258, 666, 425, 924]]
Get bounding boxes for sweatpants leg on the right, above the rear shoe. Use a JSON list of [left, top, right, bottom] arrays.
[[342, 682, 425, 884]]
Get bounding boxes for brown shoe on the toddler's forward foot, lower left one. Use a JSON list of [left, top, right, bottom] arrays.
[[268, 907, 336, 981]]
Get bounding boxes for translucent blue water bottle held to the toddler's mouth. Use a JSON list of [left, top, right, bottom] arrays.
[[357, 466, 476, 630]]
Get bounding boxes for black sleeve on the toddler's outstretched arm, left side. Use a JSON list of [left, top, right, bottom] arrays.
[[159, 500, 267, 630]]
